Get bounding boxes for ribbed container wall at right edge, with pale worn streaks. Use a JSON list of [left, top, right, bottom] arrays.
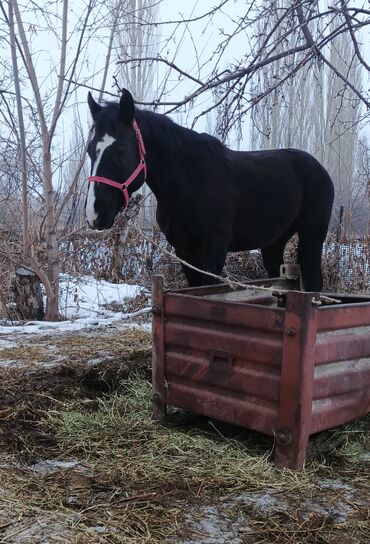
[[311, 303, 370, 433]]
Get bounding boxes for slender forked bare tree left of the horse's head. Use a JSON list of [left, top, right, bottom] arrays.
[[0, 0, 108, 320]]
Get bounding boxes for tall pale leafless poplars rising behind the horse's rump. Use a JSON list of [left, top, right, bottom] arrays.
[[252, 0, 361, 232]]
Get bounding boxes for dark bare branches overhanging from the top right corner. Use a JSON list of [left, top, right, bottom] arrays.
[[118, 0, 370, 126]]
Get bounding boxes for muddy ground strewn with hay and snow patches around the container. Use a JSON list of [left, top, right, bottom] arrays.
[[0, 323, 370, 544]]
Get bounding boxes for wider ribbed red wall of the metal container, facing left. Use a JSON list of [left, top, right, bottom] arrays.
[[164, 293, 283, 434]]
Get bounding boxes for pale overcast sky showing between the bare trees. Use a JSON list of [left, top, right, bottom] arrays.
[[3, 0, 370, 151]]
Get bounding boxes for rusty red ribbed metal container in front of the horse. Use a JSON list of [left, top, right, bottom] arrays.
[[153, 277, 370, 470]]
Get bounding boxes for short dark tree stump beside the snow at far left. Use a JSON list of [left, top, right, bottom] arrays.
[[11, 266, 45, 320]]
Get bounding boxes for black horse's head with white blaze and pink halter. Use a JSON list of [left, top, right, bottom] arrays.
[[85, 89, 146, 230]]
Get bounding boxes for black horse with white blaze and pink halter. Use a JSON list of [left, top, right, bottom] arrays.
[[86, 90, 334, 291]]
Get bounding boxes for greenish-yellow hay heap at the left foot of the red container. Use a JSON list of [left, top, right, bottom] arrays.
[[49, 378, 275, 490]]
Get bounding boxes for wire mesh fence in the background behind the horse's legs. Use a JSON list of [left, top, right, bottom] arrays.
[[61, 228, 370, 293]]
